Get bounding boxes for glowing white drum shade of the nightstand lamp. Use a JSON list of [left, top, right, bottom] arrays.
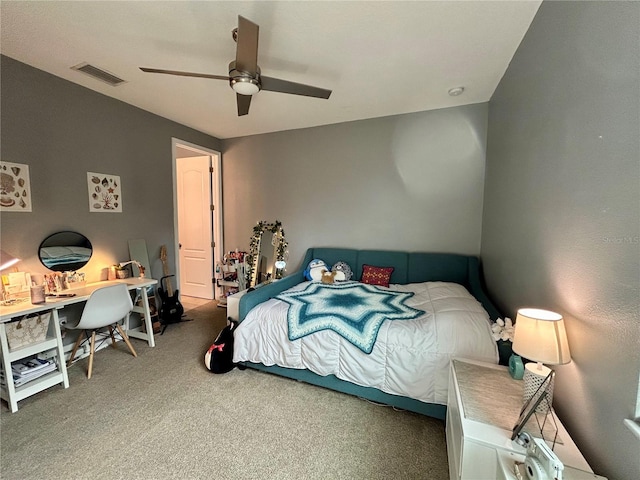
[[513, 308, 571, 365]]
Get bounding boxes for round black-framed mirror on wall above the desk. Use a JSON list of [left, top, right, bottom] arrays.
[[38, 232, 93, 272]]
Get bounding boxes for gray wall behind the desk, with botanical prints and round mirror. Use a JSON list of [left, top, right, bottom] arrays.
[[0, 56, 220, 281]]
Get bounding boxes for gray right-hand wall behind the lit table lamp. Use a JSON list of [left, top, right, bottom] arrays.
[[482, 2, 640, 480]]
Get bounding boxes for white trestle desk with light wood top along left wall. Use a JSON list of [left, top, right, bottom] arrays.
[[0, 278, 158, 412]]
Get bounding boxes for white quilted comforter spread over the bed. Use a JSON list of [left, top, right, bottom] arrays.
[[233, 282, 498, 405]]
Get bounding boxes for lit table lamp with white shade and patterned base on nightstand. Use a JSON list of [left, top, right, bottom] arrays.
[[513, 308, 571, 414]]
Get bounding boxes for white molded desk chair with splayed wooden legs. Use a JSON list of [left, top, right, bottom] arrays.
[[65, 283, 138, 378]]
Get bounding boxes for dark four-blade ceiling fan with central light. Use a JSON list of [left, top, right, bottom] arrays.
[[140, 15, 331, 116]]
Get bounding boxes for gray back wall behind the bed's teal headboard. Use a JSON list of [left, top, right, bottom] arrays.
[[223, 104, 488, 273]]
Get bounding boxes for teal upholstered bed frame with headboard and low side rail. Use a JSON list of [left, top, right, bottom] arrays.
[[239, 247, 508, 420]]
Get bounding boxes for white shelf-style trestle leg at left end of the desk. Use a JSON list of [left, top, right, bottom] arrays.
[[0, 309, 69, 413]]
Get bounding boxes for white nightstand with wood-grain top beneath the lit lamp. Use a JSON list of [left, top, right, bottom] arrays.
[[446, 359, 602, 480]]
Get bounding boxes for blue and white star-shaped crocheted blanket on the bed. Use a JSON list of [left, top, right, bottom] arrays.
[[276, 282, 424, 354]]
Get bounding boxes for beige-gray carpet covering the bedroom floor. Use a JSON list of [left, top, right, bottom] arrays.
[[0, 304, 448, 480]]
